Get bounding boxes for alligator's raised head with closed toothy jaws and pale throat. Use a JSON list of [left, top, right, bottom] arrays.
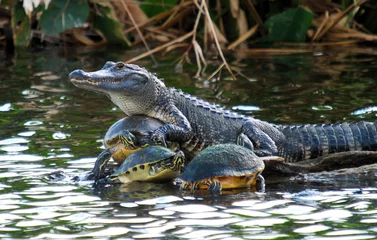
[[69, 62, 165, 115]]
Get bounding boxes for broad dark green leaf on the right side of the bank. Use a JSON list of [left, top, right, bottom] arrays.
[[266, 7, 313, 42]]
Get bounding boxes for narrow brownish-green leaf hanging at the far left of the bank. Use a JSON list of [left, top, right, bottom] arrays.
[[12, 2, 31, 47]]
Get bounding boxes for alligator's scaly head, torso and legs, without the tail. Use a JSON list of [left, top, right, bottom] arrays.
[[69, 62, 285, 156]]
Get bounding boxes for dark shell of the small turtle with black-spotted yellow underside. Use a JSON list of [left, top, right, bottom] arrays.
[[113, 146, 176, 176]]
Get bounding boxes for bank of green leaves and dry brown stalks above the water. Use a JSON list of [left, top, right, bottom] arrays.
[[0, 0, 377, 79]]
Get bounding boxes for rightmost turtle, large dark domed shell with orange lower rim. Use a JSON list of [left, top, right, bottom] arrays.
[[178, 143, 273, 192]]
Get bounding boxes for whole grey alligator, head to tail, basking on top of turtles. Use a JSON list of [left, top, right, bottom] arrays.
[[69, 62, 377, 162]]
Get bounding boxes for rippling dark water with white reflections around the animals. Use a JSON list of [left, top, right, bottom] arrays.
[[0, 47, 377, 239]]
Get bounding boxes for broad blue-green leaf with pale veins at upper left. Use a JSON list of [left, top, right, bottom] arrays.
[[39, 0, 89, 35]]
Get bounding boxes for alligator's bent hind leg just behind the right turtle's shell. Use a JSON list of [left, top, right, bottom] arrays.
[[241, 119, 278, 157]]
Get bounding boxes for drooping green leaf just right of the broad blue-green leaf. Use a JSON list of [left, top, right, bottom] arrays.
[[93, 3, 131, 47]]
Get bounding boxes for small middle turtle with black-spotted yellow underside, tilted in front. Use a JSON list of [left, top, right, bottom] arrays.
[[110, 146, 185, 183]]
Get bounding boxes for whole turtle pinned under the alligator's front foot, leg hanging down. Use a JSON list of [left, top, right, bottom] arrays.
[[91, 115, 164, 180]]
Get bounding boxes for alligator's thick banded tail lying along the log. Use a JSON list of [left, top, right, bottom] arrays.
[[278, 121, 377, 162]]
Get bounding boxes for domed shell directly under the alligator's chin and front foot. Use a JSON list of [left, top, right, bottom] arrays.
[[104, 115, 164, 147]]
